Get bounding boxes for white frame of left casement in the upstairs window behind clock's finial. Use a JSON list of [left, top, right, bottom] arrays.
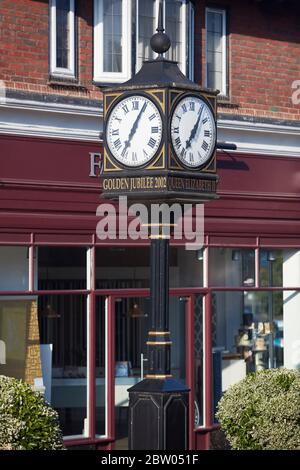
[[93, 0, 132, 83]]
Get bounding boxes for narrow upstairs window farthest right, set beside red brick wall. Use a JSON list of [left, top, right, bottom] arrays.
[[206, 8, 228, 96]]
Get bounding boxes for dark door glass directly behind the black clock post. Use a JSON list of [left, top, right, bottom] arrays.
[[113, 296, 186, 450]]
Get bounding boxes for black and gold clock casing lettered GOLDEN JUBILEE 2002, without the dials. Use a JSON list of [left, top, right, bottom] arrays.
[[102, 59, 218, 202]]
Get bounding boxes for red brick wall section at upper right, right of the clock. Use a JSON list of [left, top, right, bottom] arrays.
[[195, 0, 300, 119]]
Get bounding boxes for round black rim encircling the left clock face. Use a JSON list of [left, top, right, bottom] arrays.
[[103, 90, 166, 171]]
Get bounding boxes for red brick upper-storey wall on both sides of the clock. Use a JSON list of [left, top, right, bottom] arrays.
[[0, 0, 300, 120]]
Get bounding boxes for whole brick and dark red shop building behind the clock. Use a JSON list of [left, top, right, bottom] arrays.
[[0, 0, 300, 449]]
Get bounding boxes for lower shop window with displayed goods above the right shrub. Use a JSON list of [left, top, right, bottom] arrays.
[[212, 291, 284, 422]]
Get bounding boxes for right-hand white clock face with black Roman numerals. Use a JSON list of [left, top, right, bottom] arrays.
[[171, 96, 216, 168]]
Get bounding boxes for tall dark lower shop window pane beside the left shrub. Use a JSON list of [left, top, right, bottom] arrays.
[[38, 295, 87, 436]]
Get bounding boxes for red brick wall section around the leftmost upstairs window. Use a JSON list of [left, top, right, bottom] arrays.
[[0, 0, 101, 98]]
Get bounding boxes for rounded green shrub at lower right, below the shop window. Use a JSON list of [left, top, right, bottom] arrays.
[[217, 369, 300, 450]]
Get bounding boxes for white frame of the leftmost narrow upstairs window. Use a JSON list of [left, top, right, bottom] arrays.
[[49, 0, 75, 78]]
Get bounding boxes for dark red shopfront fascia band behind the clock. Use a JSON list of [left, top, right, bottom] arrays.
[[0, 132, 300, 246]]
